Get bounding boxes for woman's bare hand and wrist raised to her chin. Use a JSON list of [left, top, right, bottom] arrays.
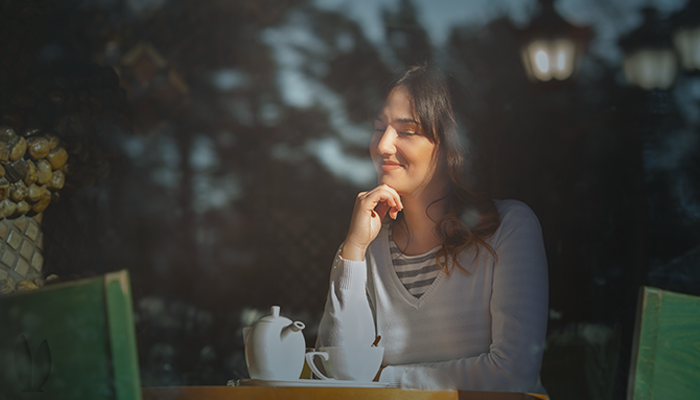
[[340, 185, 403, 261]]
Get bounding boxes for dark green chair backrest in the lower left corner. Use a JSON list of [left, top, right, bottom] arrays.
[[0, 270, 141, 400]]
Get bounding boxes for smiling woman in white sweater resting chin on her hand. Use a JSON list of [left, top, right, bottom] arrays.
[[317, 67, 548, 393]]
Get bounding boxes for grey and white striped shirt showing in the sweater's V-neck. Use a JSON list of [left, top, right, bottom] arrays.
[[389, 229, 444, 298]]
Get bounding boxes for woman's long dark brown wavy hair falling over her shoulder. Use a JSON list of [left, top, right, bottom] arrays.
[[384, 65, 501, 275]]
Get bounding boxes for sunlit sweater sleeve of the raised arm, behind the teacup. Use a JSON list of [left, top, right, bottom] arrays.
[[316, 245, 375, 347]]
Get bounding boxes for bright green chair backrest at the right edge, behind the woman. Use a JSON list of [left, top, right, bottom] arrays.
[[627, 287, 700, 400]]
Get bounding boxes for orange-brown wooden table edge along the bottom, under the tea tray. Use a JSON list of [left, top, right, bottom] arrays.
[[142, 386, 539, 400]]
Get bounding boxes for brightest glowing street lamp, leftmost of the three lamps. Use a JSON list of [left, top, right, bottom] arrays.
[[519, 0, 590, 82]]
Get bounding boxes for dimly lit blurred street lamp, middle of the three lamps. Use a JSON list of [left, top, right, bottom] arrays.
[[620, 8, 678, 90]]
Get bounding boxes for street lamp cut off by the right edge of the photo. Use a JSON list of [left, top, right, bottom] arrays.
[[673, 0, 700, 71]]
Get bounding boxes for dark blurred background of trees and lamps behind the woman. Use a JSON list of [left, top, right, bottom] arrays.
[[0, 0, 700, 399]]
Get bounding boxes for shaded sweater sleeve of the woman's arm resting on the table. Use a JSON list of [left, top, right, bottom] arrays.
[[380, 202, 548, 393]]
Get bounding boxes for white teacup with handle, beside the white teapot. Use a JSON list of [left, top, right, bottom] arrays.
[[306, 346, 384, 382]]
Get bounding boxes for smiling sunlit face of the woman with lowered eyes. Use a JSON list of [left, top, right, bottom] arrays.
[[370, 86, 447, 196]]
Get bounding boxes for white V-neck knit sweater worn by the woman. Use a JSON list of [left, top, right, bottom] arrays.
[[317, 200, 548, 394]]
